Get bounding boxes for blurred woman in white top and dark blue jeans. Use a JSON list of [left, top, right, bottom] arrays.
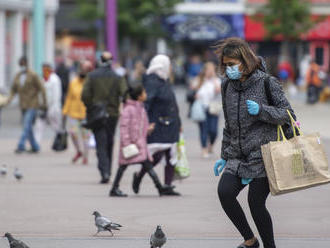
[[191, 62, 221, 158]]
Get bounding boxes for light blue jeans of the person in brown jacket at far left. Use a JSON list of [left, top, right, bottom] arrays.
[[17, 109, 40, 151]]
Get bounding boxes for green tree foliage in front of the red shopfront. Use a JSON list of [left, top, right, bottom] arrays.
[[258, 0, 316, 40]]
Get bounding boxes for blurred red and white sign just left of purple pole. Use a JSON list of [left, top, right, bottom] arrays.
[[70, 41, 96, 64]]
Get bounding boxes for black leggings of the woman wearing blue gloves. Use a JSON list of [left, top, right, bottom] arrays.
[[218, 173, 275, 248]]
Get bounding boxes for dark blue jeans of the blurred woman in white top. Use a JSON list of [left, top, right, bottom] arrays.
[[198, 112, 219, 148]]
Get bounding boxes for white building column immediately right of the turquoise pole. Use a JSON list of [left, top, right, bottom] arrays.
[[45, 14, 55, 65]]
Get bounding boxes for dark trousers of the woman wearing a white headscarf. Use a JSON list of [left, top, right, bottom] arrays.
[[139, 149, 174, 185]]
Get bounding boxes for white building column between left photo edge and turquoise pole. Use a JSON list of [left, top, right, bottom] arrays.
[[10, 12, 24, 80]]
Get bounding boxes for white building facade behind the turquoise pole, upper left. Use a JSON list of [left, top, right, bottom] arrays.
[[0, 0, 58, 91]]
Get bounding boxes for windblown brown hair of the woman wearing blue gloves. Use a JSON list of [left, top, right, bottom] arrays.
[[214, 37, 261, 75]]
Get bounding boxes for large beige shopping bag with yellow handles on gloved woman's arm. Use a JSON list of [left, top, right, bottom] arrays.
[[261, 111, 330, 195]]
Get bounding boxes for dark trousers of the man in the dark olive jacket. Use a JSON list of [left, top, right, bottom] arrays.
[[93, 118, 118, 179]]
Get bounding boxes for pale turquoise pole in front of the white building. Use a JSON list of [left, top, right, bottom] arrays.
[[33, 0, 45, 76]]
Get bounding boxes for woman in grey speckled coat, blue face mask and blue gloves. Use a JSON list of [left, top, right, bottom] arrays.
[[214, 38, 293, 248]]
